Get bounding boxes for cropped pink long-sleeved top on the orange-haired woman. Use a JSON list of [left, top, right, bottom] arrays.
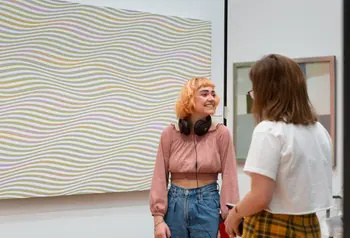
[[150, 123, 239, 216]]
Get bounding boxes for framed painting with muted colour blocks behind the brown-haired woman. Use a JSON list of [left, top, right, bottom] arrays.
[[233, 56, 336, 166]]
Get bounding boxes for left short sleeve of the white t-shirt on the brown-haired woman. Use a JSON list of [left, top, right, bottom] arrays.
[[243, 126, 282, 180]]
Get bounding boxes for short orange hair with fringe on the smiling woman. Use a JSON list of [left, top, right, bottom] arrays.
[[175, 78, 220, 119]]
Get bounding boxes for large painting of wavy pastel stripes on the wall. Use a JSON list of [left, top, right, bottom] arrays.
[[0, 0, 211, 199]]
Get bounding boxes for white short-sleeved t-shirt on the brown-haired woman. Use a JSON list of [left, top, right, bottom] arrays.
[[243, 121, 333, 215]]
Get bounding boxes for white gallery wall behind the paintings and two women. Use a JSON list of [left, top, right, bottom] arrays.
[[0, 0, 343, 238]]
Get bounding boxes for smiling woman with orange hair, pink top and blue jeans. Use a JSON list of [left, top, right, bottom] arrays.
[[150, 78, 239, 238]]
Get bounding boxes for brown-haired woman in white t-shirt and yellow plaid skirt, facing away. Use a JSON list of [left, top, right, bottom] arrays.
[[225, 54, 332, 238]]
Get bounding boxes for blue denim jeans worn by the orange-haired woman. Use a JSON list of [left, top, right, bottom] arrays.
[[164, 182, 220, 238]]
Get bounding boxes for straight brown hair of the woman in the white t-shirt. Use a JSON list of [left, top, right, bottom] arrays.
[[249, 54, 317, 125]]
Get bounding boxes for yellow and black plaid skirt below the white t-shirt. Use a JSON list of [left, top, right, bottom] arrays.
[[242, 211, 321, 238]]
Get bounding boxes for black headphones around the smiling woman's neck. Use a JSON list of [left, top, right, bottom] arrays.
[[179, 116, 211, 136]]
